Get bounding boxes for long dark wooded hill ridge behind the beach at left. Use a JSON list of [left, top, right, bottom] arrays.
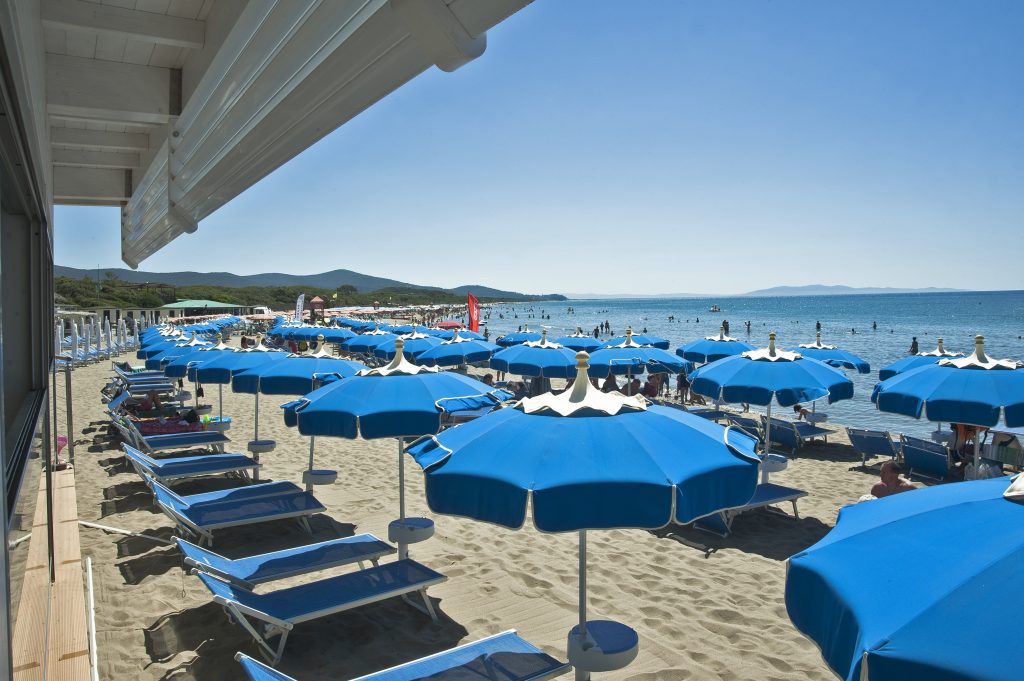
[[53, 265, 564, 300]]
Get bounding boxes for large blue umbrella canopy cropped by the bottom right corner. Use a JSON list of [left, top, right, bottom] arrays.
[[785, 477, 1024, 681]]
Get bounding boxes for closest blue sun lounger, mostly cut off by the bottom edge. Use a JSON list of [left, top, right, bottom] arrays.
[[234, 630, 572, 681]]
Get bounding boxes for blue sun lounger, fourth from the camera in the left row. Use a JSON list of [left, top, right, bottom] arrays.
[[144, 476, 327, 546]]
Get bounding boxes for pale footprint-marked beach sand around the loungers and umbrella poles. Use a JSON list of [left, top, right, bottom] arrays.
[[68, 352, 878, 681]]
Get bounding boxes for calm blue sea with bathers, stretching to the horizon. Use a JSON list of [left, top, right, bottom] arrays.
[[477, 291, 1024, 436]]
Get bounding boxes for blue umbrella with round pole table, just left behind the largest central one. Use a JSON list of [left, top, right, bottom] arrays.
[[286, 338, 508, 558]]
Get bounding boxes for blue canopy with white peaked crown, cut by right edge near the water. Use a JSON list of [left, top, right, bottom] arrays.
[[871, 336, 1024, 428]]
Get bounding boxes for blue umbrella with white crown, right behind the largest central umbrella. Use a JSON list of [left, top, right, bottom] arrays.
[[690, 334, 853, 482]]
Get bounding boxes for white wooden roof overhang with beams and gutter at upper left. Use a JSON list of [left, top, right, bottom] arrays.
[[29, 0, 529, 267]]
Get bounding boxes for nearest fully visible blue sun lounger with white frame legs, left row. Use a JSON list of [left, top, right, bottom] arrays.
[[196, 558, 447, 665]]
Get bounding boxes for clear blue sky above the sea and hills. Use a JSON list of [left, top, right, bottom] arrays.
[[55, 0, 1024, 293]]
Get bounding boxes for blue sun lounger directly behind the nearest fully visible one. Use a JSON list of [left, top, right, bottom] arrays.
[[174, 535, 395, 591]]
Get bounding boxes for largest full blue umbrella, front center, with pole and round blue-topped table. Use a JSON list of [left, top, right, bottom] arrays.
[[410, 352, 758, 678]]
